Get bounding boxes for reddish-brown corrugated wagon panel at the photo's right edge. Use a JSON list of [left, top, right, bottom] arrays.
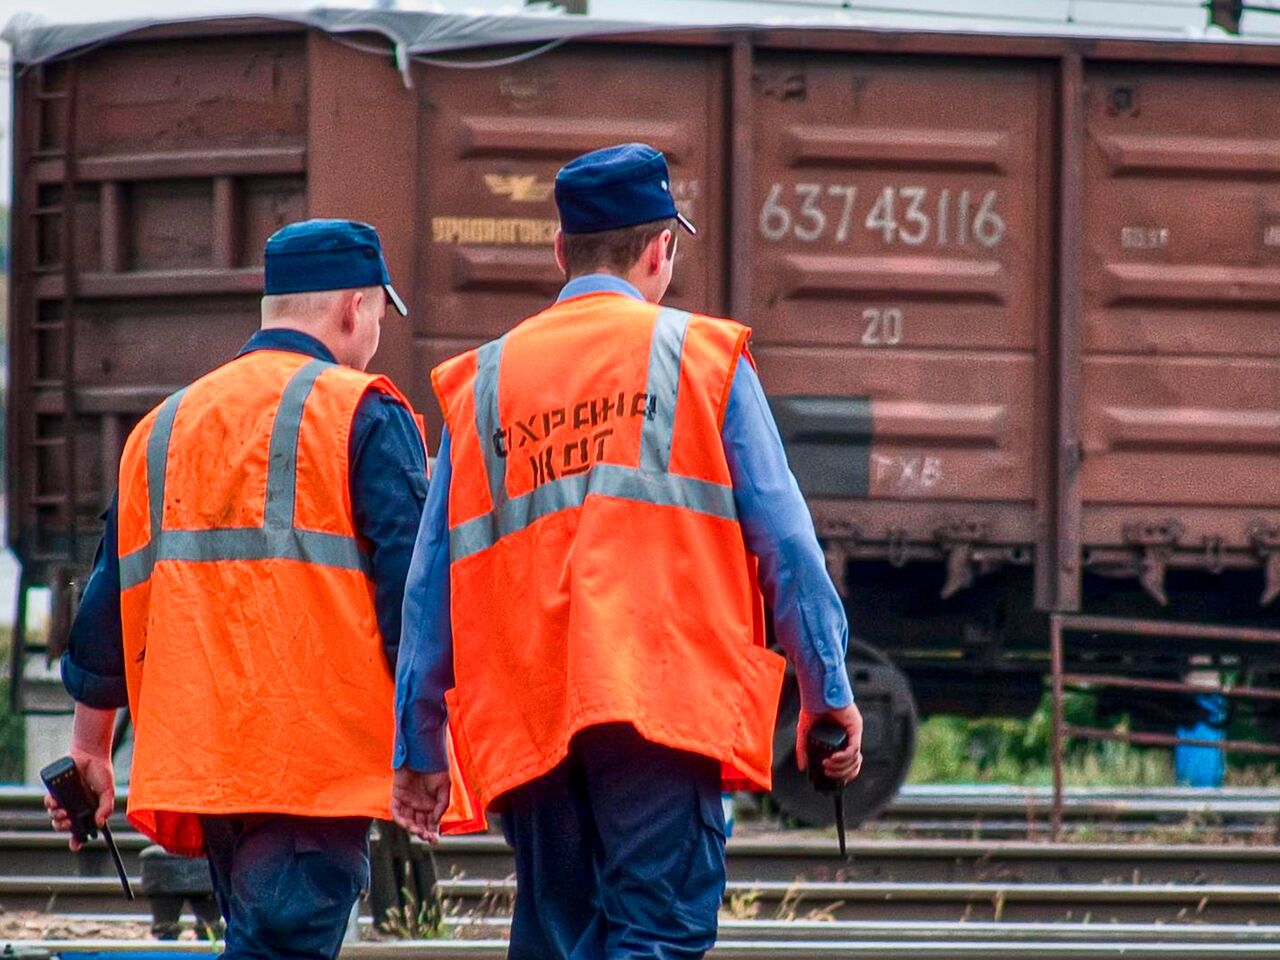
[[1083, 64, 1280, 576]]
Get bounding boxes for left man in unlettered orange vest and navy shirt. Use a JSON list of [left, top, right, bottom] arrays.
[[46, 220, 426, 960]]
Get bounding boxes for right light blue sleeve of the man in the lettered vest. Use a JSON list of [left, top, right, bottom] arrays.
[[721, 360, 854, 712]]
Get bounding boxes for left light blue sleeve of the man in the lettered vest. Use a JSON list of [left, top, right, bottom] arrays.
[[393, 430, 453, 773]]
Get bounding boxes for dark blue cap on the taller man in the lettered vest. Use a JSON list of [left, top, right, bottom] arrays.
[[556, 143, 698, 239]]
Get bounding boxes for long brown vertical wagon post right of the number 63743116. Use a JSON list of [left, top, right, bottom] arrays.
[[1055, 51, 1084, 611]]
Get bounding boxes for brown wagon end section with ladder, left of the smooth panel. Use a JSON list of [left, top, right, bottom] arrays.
[[10, 31, 307, 581]]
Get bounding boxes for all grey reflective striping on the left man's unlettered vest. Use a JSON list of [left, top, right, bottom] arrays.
[[120, 360, 371, 590]]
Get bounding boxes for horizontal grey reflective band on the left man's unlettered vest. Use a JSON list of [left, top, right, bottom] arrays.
[[120, 527, 371, 590]]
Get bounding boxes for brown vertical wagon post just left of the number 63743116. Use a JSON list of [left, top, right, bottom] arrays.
[[726, 33, 755, 324]]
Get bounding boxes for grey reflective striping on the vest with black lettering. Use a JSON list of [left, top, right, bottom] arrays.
[[449, 307, 737, 562]]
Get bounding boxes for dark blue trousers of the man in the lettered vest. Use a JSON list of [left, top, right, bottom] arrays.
[[499, 723, 724, 960]]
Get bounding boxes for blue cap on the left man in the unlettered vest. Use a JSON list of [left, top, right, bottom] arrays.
[[264, 220, 408, 316]]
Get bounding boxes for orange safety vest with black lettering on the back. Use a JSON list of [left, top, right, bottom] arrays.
[[431, 293, 783, 833]]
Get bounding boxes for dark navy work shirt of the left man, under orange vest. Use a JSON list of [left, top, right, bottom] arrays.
[[61, 328, 426, 709]]
